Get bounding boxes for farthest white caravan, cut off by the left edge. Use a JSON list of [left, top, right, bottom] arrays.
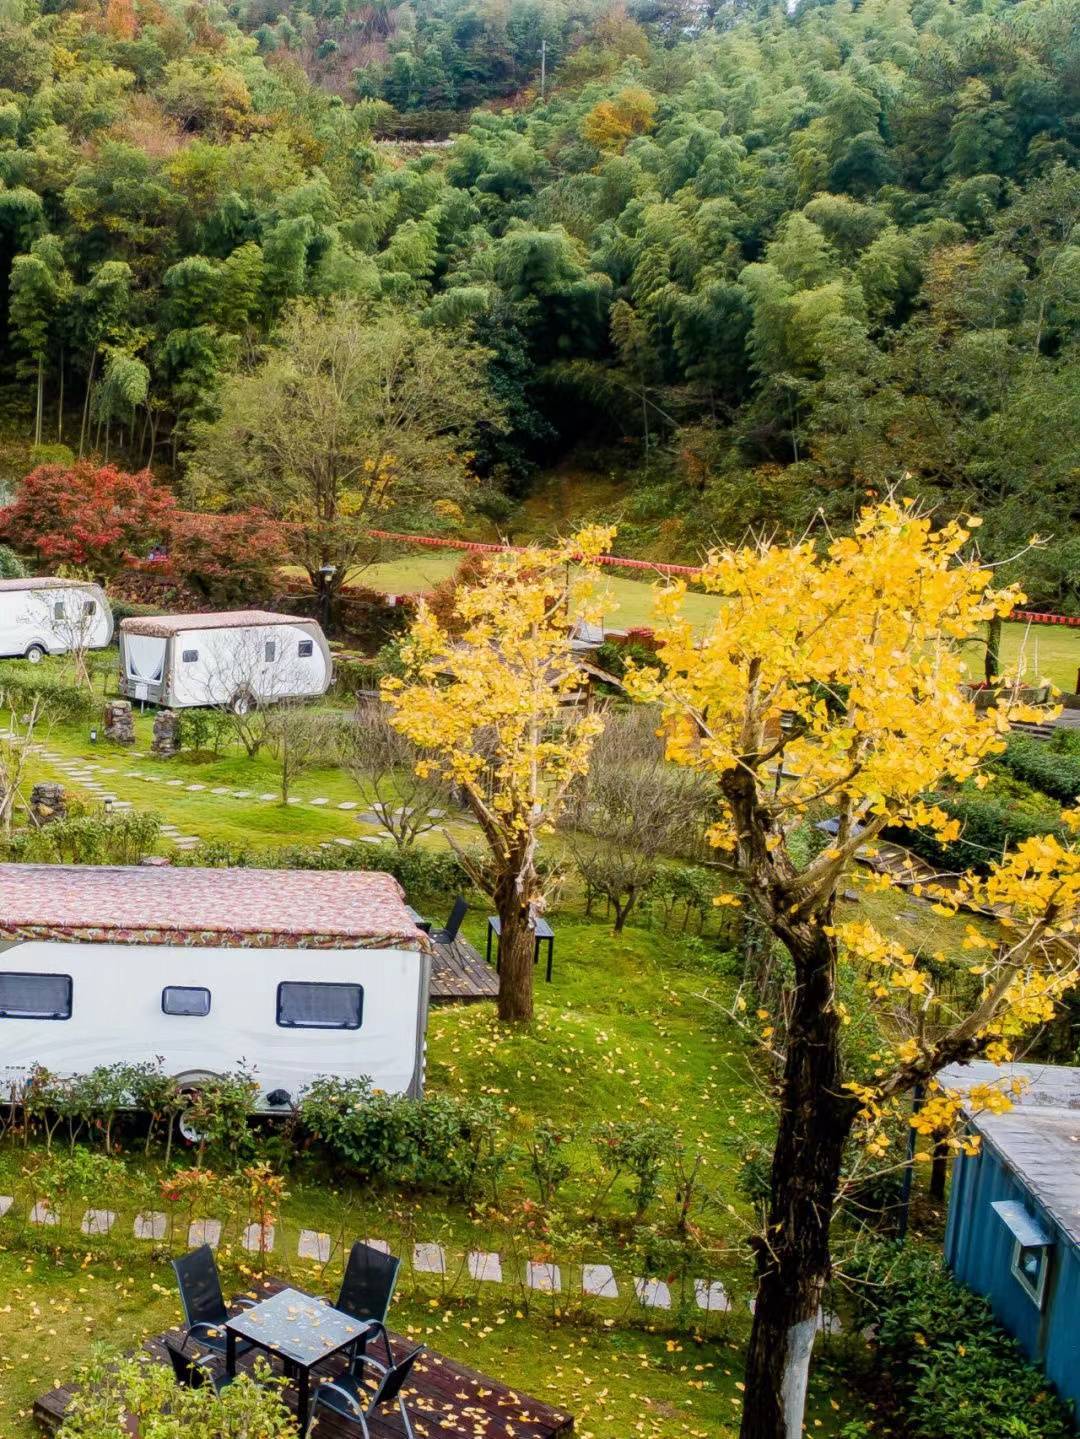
[[0, 577, 112, 665]]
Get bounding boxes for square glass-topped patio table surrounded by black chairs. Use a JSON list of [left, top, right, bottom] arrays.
[[224, 1289, 371, 1433]]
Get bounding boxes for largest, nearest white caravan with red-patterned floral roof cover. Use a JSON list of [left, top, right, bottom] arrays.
[[0, 865, 431, 1114]]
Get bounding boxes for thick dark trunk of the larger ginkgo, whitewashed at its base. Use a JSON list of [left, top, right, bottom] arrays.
[[739, 921, 857, 1439]]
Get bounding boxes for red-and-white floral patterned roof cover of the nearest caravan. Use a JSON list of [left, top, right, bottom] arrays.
[[0, 865, 427, 950]]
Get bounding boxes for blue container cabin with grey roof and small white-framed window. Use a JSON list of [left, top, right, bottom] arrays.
[[938, 1062, 1080, 1417]]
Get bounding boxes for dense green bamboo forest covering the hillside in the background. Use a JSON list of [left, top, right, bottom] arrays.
[[0, 0, 1080, 604]]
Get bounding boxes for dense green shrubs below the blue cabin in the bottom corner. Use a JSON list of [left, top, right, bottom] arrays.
[[847, 1243, 1076, 1439]]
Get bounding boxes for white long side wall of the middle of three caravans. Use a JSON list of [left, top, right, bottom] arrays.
[[163, 625, 331, 707]]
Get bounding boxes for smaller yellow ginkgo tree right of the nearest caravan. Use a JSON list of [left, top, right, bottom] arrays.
[[383, 527, 614, 1022]]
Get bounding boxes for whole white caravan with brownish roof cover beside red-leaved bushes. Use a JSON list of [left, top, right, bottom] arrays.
[[119, 610, 334, 712]]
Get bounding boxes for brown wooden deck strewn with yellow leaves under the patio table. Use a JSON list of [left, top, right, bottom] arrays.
[[33, 1281, 574, 1439]]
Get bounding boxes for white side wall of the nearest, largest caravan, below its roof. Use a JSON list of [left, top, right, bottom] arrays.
[[0, 941, 430, 1112]]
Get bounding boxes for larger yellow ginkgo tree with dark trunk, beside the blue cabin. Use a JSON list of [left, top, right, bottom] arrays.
[[630, 499, 1080, 1439]]
